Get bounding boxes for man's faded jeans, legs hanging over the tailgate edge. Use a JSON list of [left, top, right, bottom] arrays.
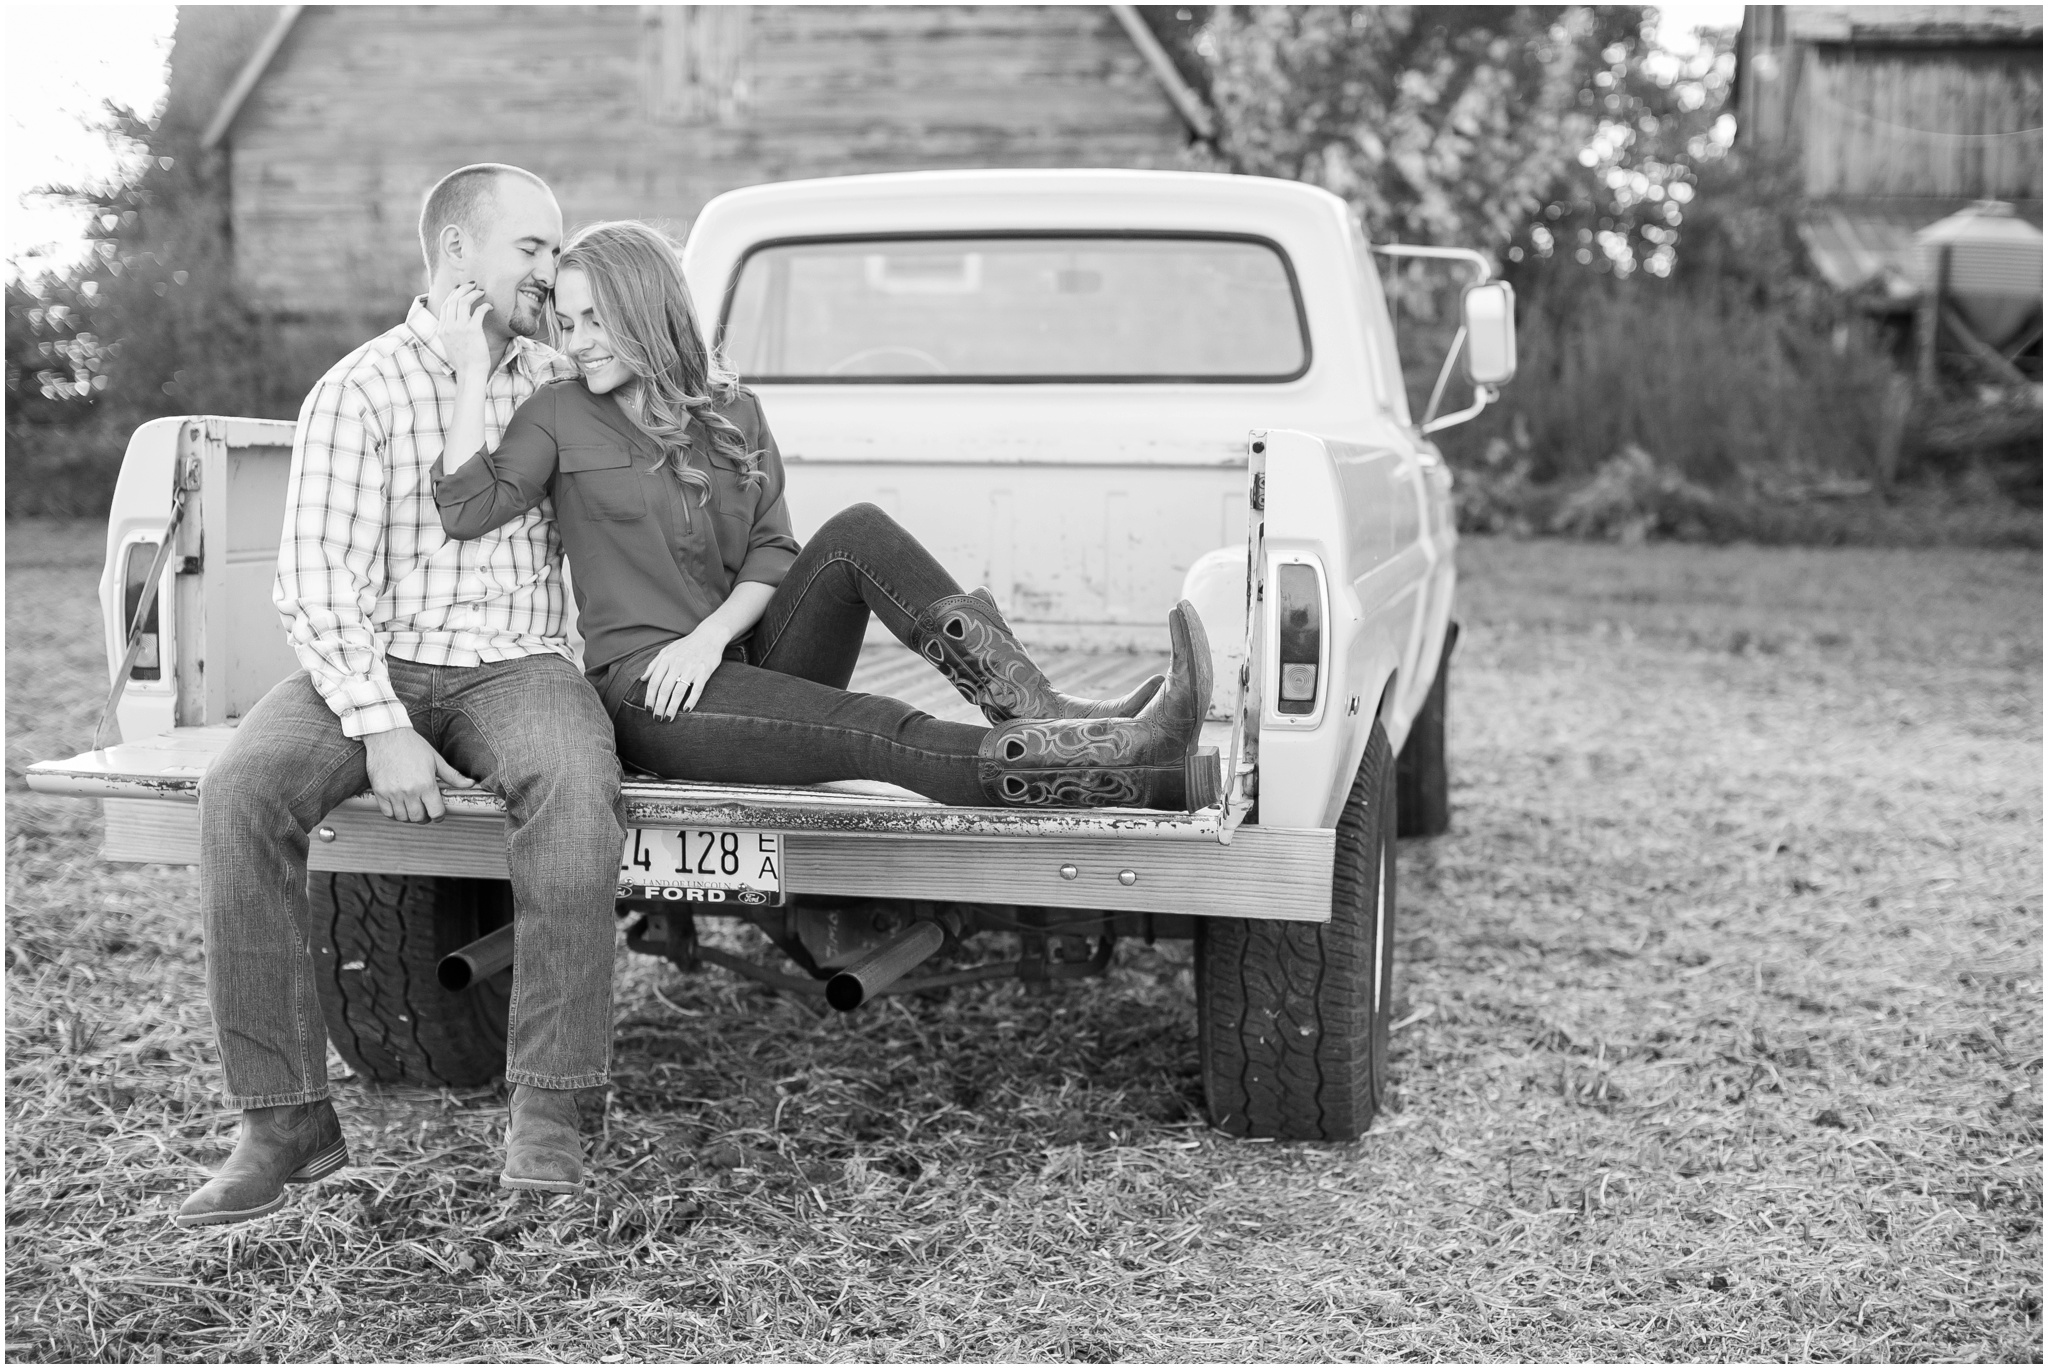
[[199, 656, 625, 1109]]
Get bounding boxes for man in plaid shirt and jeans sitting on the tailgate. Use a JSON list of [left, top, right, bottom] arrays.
[[176, 166, 625, 1226]]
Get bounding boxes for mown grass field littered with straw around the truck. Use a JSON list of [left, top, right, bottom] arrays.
[[6, 523, 2042, 1361]]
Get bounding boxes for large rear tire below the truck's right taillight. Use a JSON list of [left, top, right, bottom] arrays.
[[1194, 721, 1395, 1142]]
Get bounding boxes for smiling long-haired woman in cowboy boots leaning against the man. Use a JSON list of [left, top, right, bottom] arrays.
[[434, 223, 1219, 810]]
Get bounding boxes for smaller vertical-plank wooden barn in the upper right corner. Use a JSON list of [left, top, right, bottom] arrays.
[[1737, 4, 2042, 297]]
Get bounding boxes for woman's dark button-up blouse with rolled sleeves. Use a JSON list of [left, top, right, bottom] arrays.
[[432, 381, 797, 713]]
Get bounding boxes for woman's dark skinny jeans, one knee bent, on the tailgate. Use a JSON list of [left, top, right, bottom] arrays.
[[612, 504, 989, 805]]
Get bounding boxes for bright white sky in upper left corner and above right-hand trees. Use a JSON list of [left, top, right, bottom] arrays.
[[0, 0, 1743, 279]]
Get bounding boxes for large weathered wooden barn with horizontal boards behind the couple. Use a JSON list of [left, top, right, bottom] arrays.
[[192, 4, 1208, 332]]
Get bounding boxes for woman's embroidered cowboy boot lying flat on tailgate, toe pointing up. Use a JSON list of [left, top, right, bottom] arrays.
[[979, 600, 1223, 812]]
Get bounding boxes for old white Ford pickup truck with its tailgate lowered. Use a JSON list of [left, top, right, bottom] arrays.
[[29, 170, 1513, 1139]]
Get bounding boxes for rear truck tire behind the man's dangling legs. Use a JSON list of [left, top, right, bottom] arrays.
[[307, 871, 512, 1088]]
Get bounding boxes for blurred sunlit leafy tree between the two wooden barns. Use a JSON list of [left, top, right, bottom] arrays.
[[1194, 4, 1753, 281]]
